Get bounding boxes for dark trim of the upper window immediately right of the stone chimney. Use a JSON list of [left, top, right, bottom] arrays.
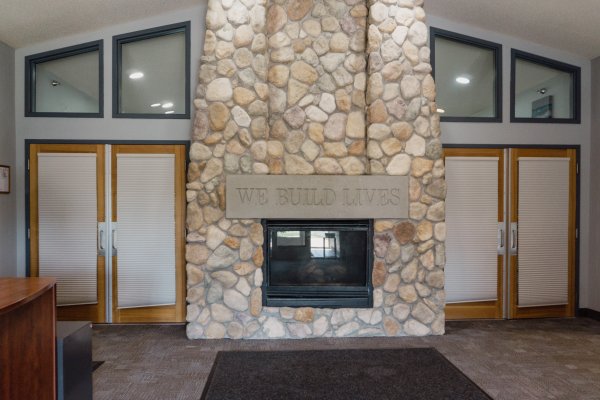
[[430, 27, 502, 122]]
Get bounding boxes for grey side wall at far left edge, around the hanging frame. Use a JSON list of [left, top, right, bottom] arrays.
[[0, 42, 17, 276]]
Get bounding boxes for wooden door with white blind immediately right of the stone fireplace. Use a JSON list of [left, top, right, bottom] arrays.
[[444, 148, 505, 319]]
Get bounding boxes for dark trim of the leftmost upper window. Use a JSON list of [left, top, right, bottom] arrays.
[[25, 40, 104, 118]]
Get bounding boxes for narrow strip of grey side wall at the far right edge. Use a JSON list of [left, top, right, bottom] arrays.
[[588, 57, 600, 311]]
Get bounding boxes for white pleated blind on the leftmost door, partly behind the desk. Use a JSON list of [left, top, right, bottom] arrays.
[[38, 153, 98, 306]]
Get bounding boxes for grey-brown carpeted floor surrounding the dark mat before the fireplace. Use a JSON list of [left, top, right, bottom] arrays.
[[92, 318, 600, 400]]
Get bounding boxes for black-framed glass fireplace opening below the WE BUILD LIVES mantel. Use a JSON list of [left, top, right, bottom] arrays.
[[263, 220, 373, 308]]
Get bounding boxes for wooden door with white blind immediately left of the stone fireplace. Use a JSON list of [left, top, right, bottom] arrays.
[[111, 145, 186, 322]]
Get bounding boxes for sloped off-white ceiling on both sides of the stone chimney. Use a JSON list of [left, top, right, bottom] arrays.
[[0, 0, 600, 59]]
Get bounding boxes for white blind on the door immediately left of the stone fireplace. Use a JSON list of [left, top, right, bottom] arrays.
[[116, 154, 175, 308]]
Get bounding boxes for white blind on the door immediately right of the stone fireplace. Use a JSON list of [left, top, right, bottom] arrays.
[[445, 157, 498, 303]]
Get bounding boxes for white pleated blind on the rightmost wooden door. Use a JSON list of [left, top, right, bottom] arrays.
[[518, 157, 569, 307]]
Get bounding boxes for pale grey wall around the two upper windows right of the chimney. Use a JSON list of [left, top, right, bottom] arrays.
[[425, 14, 600, 308]]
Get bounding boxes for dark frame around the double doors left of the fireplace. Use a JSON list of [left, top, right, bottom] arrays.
[[24, 139, 191, 319]]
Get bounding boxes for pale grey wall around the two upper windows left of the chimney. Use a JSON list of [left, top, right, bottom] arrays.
[[13, 1, 207, 276]]
